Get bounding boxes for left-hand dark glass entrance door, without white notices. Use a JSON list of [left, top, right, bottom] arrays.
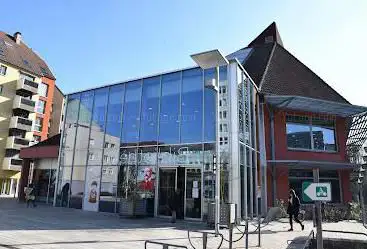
[[158, 168, 177, 216]]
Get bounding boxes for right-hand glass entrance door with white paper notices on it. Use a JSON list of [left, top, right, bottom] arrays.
[[185, 168, 201, 219]]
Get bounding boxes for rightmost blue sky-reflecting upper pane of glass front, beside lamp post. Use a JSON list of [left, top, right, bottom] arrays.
[[204, 69, 217, 142]]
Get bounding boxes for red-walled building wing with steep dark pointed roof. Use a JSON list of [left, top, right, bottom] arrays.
[[243, 23, 365, 206]]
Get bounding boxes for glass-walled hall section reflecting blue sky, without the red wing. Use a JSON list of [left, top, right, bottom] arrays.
[[55, 54, 258, 220]]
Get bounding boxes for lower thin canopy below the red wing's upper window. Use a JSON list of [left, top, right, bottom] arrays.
[[267, 160, 359, 170]]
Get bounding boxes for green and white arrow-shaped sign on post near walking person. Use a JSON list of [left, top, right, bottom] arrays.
[[302, 182, 331, 202]]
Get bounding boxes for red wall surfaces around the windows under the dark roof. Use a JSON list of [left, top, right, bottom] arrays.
[[264, 106, 352, 206]]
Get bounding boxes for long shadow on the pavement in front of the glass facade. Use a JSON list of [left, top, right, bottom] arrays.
[[0, 198, 208, 231]]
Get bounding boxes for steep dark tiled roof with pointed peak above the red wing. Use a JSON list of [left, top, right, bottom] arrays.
[[243, 23, 349, 104]]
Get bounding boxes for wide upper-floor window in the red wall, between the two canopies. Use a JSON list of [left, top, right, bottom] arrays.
[[286, 115, 336, 151]]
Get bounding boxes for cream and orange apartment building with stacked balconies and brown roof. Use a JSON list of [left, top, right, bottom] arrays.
[[0, 32, 62, 195]]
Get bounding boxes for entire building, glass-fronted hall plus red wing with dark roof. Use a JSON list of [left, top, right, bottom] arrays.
[[52, 23, 367, 221]]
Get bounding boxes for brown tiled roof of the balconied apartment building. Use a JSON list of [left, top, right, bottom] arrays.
[[0, 31, 55, 79]]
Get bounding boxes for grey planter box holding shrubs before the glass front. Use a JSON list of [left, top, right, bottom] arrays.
[[119, 199, 148, 217]]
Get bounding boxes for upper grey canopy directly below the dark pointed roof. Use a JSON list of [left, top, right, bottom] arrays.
[[265, 95, 367, 118]]
